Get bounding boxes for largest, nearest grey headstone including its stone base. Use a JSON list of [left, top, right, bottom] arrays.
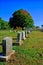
[[0, 37, 15, 61]]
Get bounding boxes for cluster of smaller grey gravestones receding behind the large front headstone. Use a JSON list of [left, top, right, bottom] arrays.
[[16, 31, 30, 45]]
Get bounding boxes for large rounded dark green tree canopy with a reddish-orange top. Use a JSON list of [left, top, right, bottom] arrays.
[[9, 9, 34, 28]]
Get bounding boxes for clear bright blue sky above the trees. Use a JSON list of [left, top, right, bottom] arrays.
[[0, 0, 43, 26]]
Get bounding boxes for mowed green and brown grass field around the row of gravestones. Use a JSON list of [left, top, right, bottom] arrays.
[[0, 31, 43, 65]]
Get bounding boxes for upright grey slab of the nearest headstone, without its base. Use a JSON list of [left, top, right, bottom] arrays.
[[2, 37, 12, 56]]
